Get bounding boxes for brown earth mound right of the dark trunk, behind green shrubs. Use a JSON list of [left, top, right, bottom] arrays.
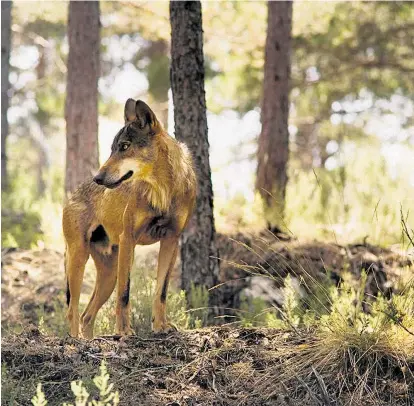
[[217, 232, 414, 309]]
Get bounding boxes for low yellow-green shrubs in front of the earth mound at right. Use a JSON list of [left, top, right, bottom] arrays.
[[239, 266, 414, 352]]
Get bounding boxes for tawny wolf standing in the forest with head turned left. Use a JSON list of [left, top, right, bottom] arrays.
[[62, 99, 197, 339]]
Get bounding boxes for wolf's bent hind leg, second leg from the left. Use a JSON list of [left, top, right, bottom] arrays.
[[81, 245, 118, 339]]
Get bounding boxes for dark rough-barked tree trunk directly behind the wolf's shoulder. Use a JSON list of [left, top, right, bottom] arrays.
[[170, 1, 219, 313]]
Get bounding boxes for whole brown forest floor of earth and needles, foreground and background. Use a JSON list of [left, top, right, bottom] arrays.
[[1, 236, 414, 406]]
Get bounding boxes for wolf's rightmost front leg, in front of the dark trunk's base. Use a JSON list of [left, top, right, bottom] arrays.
[[152, 237, 178, 333]]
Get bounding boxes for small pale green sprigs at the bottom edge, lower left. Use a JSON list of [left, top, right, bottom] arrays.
[[32, 361, 119, 406]]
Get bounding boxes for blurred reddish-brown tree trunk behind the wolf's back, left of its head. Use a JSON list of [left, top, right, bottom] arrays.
[[65, 1, 100, 195]]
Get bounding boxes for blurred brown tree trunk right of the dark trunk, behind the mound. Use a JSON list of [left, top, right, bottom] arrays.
[[256, 1, 292, 232]]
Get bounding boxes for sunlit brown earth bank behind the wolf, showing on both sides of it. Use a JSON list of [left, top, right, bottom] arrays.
[[1, 233, 414, 329]]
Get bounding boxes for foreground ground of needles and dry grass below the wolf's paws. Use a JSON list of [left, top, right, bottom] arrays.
[[2, 327, 414, 406]]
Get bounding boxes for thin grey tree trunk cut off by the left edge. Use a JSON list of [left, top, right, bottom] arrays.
[[1, 1, 12, 191]]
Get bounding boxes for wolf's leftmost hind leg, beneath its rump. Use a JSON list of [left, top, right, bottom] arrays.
[[65, 243, 89, 337]]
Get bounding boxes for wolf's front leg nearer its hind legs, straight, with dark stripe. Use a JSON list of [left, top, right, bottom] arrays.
[[116, 232, 135, 335]]
